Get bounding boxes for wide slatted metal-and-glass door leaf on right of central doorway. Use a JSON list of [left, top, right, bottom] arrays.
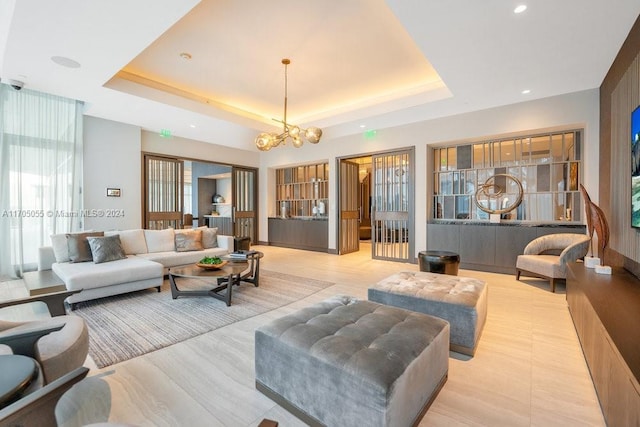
[[371, 150, 415, 262]]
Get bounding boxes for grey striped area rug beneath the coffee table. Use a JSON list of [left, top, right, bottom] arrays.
[[72, 270, 333, 368]]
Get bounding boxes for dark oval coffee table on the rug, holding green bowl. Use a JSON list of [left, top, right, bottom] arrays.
[[169, 261, 258, 307]]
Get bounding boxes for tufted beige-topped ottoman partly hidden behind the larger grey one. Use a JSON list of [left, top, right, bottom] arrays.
[[369, 271, 487, 356]]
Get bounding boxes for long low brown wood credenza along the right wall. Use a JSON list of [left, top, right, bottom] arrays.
[[567, 262, 640, 426]]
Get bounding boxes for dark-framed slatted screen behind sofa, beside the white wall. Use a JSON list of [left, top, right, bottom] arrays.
[[144, 155, 184, 230]]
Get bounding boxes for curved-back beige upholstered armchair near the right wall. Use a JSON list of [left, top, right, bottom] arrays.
[[516, 233, 591, 292]]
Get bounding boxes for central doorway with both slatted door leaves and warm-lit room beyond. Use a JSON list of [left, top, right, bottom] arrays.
[[337, 148, 415, 263]]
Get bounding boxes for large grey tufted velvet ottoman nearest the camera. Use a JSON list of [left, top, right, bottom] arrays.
[[255, 296, 449, 426]]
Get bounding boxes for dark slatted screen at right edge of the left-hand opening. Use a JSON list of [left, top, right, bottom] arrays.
[[231, 167, 258, 244]]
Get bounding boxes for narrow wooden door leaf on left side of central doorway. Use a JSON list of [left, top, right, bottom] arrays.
[[340, 160, 361, 254]]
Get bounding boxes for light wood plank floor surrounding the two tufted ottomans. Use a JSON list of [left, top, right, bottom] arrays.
[[3, 246, 605, 427]]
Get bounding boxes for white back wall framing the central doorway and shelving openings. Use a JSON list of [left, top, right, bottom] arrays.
[[259, 89, 600, 252]]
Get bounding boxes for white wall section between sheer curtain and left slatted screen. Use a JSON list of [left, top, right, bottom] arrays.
[[83, 116, 142, 230]]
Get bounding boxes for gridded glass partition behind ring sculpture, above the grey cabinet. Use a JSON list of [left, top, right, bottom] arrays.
[[431, 130, 582, 222]]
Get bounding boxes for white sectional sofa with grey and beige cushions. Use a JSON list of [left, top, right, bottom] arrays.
[[38, 227, 234, 309]]
